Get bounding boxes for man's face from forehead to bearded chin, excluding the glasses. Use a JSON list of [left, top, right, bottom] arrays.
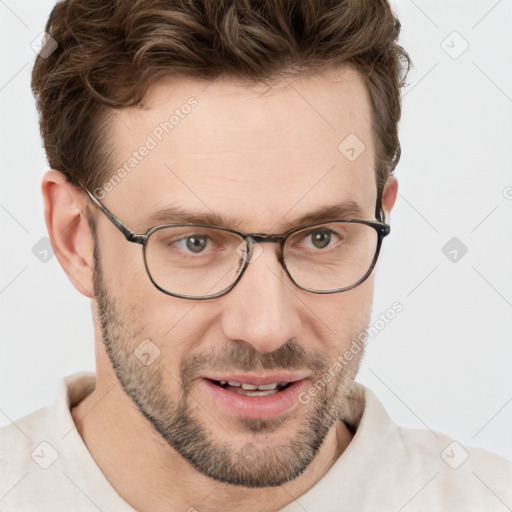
[[91, 66, 376, 487]]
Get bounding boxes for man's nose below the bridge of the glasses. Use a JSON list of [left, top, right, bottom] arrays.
[[222, 243, 306, 353]]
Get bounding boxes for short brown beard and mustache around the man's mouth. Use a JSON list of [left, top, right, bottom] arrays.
[[93, 229, 363, 488]]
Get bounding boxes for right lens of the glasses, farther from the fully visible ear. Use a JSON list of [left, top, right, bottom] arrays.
[[283, 222, 379, 291]]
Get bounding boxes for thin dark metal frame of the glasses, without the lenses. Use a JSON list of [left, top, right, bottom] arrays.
[[80, 185, 391, 300]]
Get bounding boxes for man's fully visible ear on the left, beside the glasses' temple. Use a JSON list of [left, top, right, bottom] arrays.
[[41, 169, 94, 298]]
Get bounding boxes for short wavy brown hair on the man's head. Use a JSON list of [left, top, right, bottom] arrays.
[[31, 0, 411, 207]]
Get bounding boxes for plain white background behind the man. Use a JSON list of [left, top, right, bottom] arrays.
[[0, 0, 512, 459]]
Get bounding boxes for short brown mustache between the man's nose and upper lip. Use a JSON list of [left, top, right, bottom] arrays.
[[180, 339, 329, 388]]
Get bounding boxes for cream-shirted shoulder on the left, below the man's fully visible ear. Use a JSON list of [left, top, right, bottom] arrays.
[[0, 372, 109, 512]]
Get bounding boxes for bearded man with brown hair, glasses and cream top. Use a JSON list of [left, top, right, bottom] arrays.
[[0, 0, 512, 512]]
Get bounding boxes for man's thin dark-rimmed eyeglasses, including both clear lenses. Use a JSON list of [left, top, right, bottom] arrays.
[[82, 187, 391, 300]]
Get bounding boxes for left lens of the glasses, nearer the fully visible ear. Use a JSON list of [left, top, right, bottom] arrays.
[[145, 226, 246, 297]]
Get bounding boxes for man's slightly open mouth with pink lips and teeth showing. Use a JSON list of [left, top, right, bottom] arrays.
[[198, 372, 310, 419]]
